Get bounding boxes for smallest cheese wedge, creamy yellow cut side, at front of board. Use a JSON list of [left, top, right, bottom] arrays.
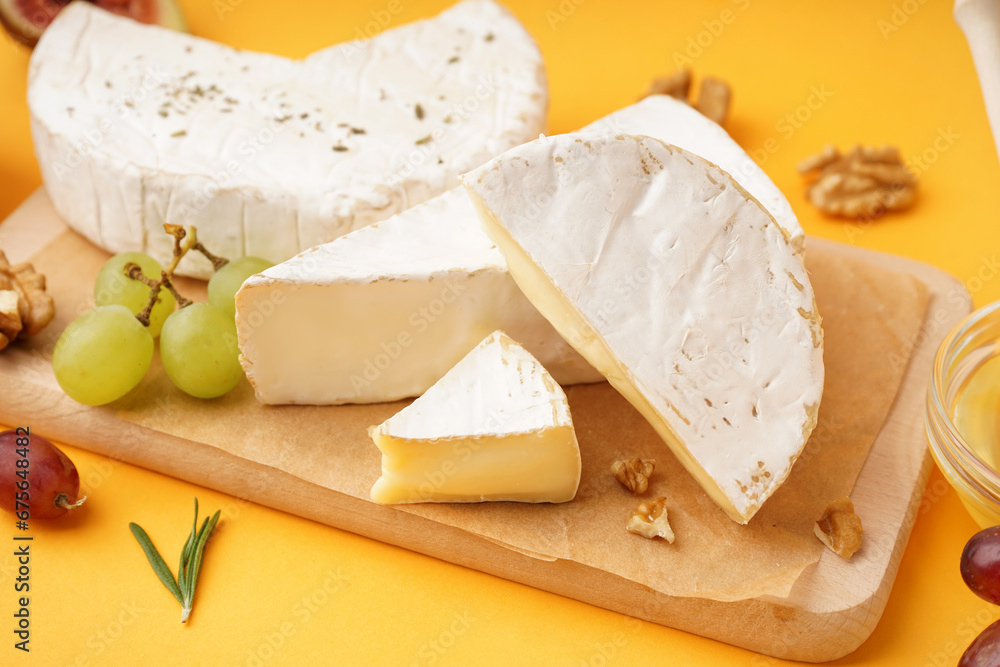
[[371, 331, 581, 504]]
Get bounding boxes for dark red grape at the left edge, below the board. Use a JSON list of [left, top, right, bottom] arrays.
[[0, 430, 83, 519]]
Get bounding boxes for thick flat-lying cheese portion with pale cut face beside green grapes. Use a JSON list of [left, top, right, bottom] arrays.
[[236, 188, 603, 405]]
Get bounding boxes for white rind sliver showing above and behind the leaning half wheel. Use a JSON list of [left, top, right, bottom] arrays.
[[581, 95, 805, 252]]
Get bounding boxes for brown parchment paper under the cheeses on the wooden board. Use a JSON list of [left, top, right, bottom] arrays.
[[31, 234, 928, 601]]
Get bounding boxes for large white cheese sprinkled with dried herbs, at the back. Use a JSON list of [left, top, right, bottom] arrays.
[[28, 0, 547, 277]]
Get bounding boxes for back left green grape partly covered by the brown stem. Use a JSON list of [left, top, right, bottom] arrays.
[[94, 252, 177, 338]]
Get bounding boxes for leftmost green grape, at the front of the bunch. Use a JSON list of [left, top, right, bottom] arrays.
[[52, 304, 153, 405]]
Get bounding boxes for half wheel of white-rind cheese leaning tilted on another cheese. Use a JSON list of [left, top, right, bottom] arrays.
[[462, 133, 823, 523]]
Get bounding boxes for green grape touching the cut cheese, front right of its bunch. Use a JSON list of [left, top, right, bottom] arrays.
[[160, 303, 243, 398]]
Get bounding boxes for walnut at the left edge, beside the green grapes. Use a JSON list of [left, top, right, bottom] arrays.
[[0, 250, 56, 350]]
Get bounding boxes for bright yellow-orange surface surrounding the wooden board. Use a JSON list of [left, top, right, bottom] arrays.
[[0, 0, 1000, 667]]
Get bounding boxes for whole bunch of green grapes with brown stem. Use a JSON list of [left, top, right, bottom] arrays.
[[52, 225, 271, 405]]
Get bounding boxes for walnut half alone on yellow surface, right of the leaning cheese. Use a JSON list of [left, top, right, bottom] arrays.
[[799, 146, 917, 219]]
